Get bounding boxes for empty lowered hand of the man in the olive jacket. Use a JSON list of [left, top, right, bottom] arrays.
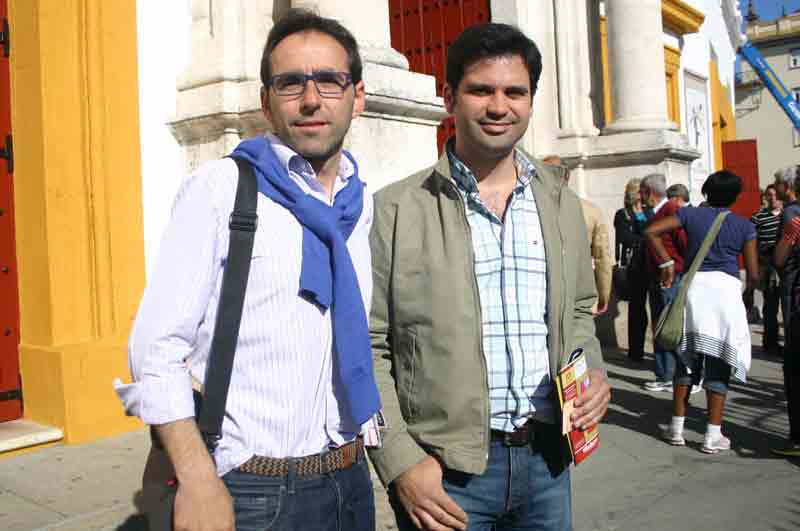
[[394, 456, 467, 531]]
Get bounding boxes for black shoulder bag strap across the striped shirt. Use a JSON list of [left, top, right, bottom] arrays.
[[197, 157, 258, 455]]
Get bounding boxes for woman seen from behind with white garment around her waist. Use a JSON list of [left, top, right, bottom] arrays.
[[646, 170, 758, 454]]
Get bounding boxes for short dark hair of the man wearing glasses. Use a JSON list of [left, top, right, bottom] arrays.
[[261, 8, 363, 87]]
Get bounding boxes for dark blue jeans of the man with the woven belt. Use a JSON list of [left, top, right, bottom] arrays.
[[222, 459, 375, 531]]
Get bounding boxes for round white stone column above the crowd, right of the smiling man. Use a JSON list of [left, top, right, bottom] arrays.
[[603, 0, 677, 134]]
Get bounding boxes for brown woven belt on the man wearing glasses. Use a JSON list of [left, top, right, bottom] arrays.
[[239, 437, 364, 477]]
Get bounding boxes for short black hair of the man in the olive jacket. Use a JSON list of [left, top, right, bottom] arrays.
[[447, 23, 542, 95]]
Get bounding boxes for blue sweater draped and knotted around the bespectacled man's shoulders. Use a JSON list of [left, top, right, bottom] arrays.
[[231, 136, 381, 425]]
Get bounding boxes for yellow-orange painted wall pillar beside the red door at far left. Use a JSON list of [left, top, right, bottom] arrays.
[[9, 0, 144, 443]]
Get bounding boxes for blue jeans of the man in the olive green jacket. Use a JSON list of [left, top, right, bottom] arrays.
[[389, 424, 572, 531]]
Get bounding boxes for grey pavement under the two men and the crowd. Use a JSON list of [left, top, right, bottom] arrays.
[[0, 335, 800, 531]]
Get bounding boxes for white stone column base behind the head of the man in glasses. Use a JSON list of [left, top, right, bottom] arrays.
[[170, 0, 445, 191]]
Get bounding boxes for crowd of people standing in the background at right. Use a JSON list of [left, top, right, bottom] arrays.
[[613, 166, 800, 457]]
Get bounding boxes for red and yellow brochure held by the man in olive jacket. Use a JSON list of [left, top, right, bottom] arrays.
[[556, 353, 600, 465]]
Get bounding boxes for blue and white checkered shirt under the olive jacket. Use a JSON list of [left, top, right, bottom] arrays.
[[448, 150, 555, 431]]
